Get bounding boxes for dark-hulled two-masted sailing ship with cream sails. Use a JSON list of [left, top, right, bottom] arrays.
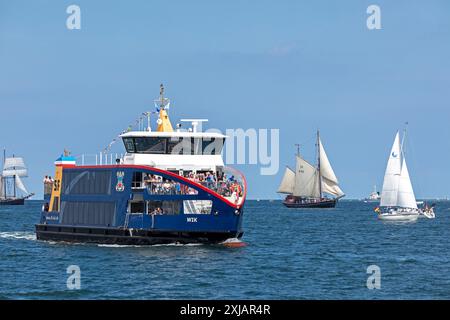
[[277, 131, 345, 208]]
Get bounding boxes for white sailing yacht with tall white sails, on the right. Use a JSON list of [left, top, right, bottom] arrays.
[[376, 132, 434, 221]]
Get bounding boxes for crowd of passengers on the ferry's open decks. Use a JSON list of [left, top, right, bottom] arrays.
[[143, 172, 242, 201]]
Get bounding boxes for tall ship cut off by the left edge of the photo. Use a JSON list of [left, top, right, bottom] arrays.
[[0, 150, 34, 205]]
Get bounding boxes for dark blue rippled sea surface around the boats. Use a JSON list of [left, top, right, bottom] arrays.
[[0, 201, 450, 299]]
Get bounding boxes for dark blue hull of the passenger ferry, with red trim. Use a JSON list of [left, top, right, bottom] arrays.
[[36, 165, 243, 245]]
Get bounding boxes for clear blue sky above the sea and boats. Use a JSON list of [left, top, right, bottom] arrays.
[[0, 0, 450, 198]]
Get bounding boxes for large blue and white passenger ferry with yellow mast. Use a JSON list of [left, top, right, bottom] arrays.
[[35, 85, 247, 245]]
